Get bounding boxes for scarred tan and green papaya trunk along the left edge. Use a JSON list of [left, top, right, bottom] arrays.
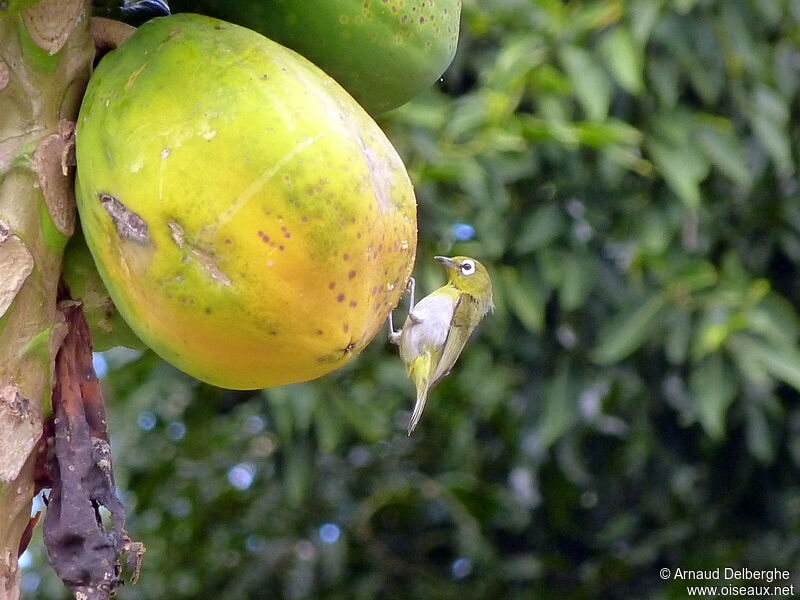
[[0, 0, 94, 600]]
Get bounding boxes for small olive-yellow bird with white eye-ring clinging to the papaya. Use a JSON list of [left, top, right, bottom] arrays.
[[389, 256, 494, 435]]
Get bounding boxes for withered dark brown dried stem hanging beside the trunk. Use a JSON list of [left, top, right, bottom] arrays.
[[44, 301, 144, 600]]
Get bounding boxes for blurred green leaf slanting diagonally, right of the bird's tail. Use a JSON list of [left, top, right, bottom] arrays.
[[593, 292, 666, 364]]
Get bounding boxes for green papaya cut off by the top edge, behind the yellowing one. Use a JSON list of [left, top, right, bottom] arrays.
[[170, 0, 461, 115]]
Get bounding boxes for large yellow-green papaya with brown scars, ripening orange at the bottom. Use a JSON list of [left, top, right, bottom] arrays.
[[76, 14, 417, 389]]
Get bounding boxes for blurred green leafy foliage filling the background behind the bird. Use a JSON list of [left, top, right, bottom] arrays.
[[21, 0, 800, 600]]
